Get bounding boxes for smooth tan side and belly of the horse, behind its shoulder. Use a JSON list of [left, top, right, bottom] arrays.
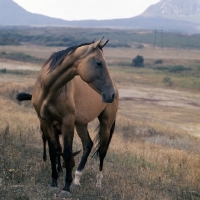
[[72, 76, 106, 124]]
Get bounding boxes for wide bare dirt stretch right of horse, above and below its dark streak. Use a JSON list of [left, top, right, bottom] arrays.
[[119, 86, 200, 136]]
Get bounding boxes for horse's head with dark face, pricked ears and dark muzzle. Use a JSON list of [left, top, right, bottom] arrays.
[[77, 39, 116, 103]]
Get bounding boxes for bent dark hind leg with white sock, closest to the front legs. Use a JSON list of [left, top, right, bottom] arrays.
[[74, 124, 93, 185]]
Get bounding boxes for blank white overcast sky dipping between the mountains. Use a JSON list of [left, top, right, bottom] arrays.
[[13, 0, 160, 20]]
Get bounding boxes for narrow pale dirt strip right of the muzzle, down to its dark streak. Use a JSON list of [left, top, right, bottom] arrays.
[[119, 87, 200, 109]]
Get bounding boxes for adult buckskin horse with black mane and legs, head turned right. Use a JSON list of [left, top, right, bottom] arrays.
[[17, 39, 119, 197]]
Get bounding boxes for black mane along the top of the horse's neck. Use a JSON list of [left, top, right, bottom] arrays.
[[43, 41, 101, 72]]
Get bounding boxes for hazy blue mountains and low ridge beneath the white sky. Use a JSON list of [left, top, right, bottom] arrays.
[[0, 0, 200, 33]]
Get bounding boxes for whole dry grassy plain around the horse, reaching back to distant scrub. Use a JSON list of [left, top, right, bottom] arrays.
[[0, 28, 200, 200]]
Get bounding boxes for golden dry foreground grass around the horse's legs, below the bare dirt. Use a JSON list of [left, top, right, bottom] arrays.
[[0, 74, 200, 200]]
